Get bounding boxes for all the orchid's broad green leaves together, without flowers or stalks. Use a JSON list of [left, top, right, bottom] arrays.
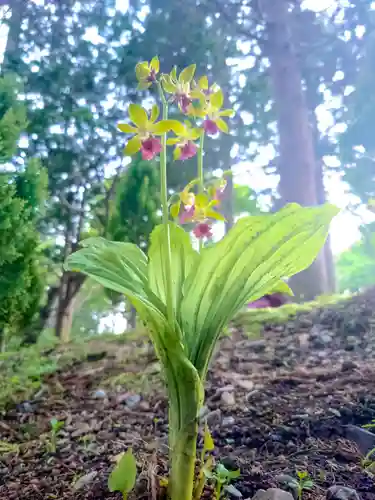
[[67, 204, 337, 500]]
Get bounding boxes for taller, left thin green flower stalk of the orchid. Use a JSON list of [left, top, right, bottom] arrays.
[[158, 82, 174, 328]]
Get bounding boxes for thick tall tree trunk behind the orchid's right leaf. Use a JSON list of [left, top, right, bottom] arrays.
[[259, 0, 327, 300]]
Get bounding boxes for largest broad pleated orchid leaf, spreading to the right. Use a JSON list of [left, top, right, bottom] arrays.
[[181, 204, 338, 379]]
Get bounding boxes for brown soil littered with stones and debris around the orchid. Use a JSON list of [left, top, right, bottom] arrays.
[[0, 291, 375, 500]]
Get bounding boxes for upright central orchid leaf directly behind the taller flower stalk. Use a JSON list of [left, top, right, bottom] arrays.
[[148, 222, 199, 321]]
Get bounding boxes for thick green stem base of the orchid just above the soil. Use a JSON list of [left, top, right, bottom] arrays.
[[170, 421, 198, 500]]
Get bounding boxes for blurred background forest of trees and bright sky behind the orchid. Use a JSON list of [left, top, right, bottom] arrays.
[[0, 0, 375, 348]]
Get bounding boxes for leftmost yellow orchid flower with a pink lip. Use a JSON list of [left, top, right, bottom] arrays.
[[118, 104, 181, 160]]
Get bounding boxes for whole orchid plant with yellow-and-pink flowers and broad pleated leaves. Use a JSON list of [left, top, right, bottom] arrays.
[[66, 57, 338, 500]]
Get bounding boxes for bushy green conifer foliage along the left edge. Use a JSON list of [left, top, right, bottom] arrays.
[[0, 76, 46, 346]]
